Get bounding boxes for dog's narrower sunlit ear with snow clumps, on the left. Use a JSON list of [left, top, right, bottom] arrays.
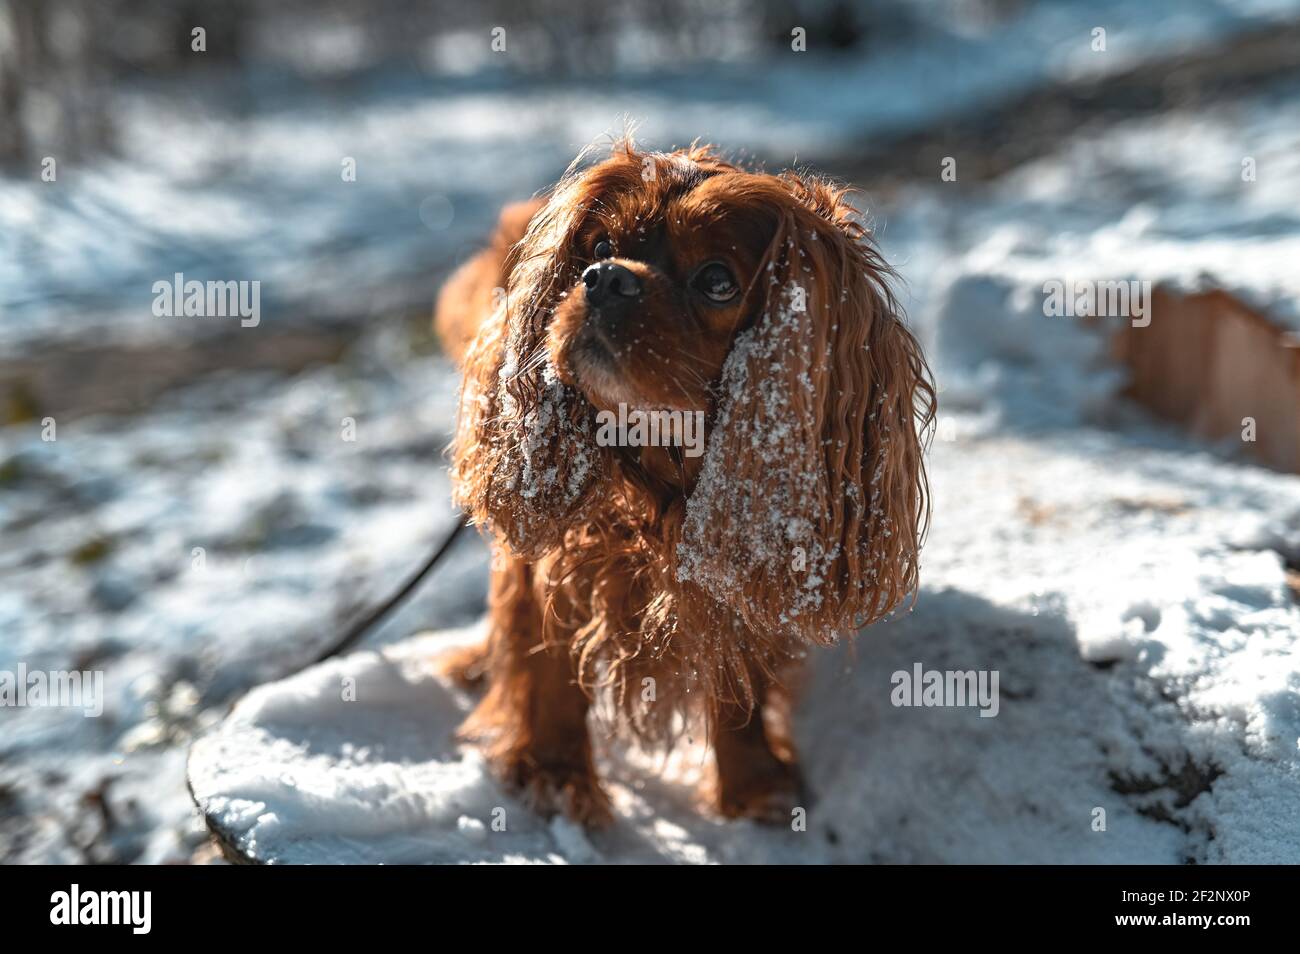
[[451, 170, 608, 556]]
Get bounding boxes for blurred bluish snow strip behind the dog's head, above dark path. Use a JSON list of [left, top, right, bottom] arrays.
[[0, 0, 1300, 354]]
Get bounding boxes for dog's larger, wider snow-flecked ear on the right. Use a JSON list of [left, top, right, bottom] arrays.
[[675, 174, 935, 642]]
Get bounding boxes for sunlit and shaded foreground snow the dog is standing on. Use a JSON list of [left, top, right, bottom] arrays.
[[191, 430, 1300, 863]]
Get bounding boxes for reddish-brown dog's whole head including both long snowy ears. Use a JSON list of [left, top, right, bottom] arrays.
[[454, 143, 933, 639]]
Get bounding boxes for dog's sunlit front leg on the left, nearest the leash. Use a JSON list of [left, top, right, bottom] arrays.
[[460, 558, 612, 827]]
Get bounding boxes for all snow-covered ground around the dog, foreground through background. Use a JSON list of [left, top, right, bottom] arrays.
[[0, 1, 1300, 862]]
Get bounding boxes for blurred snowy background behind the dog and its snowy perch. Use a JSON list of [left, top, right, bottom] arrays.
[[0, 0, 1300, 863]]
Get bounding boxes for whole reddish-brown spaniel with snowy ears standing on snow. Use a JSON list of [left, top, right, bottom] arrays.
[[436, 140, 935, 825]]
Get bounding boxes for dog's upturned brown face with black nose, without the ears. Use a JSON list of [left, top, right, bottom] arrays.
[[547, 160, 776, 412]]
